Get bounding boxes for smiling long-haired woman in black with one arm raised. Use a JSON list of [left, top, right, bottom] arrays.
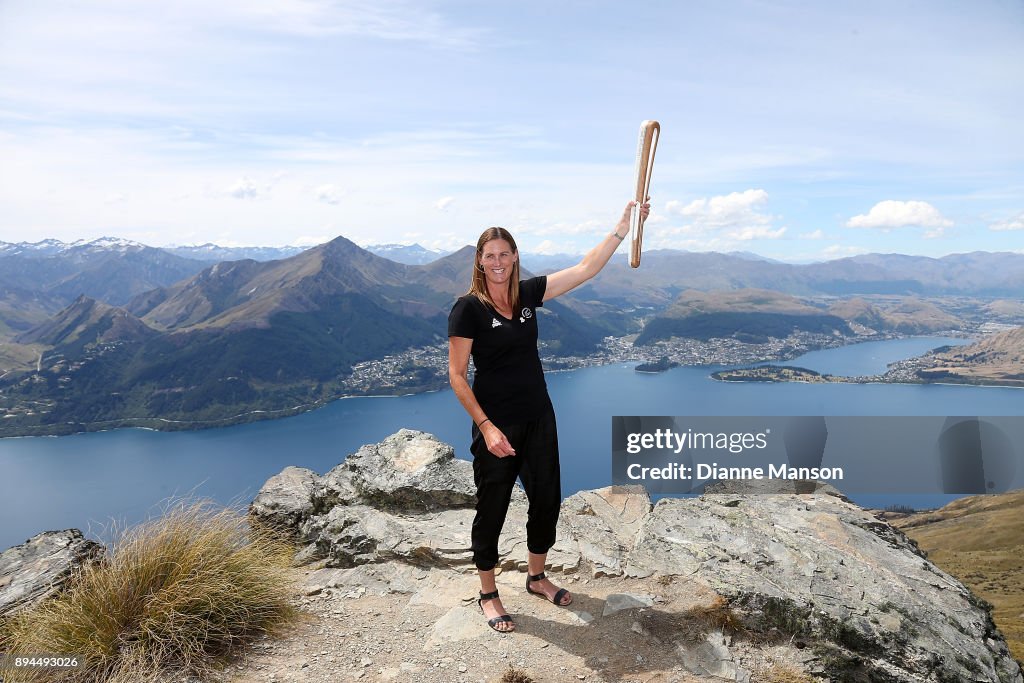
[[449, 198, 650, 633]]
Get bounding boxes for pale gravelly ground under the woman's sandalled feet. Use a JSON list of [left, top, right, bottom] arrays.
[[216, 567, 813, 683]]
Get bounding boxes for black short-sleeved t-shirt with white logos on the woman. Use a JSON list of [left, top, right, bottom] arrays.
[[449, 275, 551, 427]]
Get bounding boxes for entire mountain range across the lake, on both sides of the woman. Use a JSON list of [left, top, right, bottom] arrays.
[[0, 238, 1024, 433]]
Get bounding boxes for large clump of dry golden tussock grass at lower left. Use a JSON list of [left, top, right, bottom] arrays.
[[4, 503, 298, 683]]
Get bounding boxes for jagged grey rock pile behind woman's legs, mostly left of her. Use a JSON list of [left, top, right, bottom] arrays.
[[250, 429, 580, 571]]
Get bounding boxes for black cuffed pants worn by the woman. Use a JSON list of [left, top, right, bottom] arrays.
[[470, 409, 562, 570]]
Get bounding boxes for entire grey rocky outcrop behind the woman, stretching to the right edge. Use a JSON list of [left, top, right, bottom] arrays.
[[251, 430, 1024, 683]]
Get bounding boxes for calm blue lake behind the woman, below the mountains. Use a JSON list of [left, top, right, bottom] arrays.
[[0, 338, 1011, 549]]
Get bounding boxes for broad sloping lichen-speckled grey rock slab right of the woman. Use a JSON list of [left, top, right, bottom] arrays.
[[627, 494, 1022, 683]]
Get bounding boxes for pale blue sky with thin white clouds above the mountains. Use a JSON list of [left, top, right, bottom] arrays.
[[0, 0, 1024, 260]]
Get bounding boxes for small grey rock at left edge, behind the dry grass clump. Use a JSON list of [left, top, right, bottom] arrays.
[[0, 528, 103, 616]]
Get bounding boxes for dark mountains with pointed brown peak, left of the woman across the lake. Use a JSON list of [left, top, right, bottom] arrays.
[[0, 238, 602, 433]]
